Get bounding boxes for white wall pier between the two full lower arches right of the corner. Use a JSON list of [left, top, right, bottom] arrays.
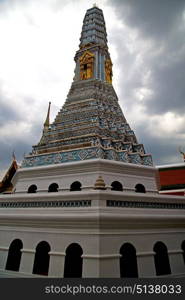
[[136, 251, 156, 277]]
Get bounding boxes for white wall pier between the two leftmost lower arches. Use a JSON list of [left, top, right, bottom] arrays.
[[19, 248, 36, 274]]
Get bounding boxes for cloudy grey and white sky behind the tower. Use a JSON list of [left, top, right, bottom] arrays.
[[0, 0, 185, 177]]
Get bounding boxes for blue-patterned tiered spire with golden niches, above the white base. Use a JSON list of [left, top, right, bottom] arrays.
[[22, 7, 152, 167]]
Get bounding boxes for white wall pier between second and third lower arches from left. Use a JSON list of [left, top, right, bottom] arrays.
[[48, 251, 66, 277]]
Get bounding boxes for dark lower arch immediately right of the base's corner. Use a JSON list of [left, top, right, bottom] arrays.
[[120, 243, 138, 278]]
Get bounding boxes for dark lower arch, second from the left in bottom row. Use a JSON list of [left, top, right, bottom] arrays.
[[33, 241, 51, 276]]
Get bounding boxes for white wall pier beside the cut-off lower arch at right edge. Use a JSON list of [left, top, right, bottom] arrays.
[[168, 249, 185, 275]]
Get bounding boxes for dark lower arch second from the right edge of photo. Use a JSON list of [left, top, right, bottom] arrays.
[[154, 242, 171, 275]]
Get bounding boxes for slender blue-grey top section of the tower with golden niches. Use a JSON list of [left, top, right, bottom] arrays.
[[74, 6, 112, 84]]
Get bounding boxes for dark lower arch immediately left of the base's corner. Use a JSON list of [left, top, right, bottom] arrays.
[[64, 243, 83, 278]]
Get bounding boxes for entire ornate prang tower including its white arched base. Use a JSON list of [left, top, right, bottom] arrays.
[[0, 7, 185, 277]]
